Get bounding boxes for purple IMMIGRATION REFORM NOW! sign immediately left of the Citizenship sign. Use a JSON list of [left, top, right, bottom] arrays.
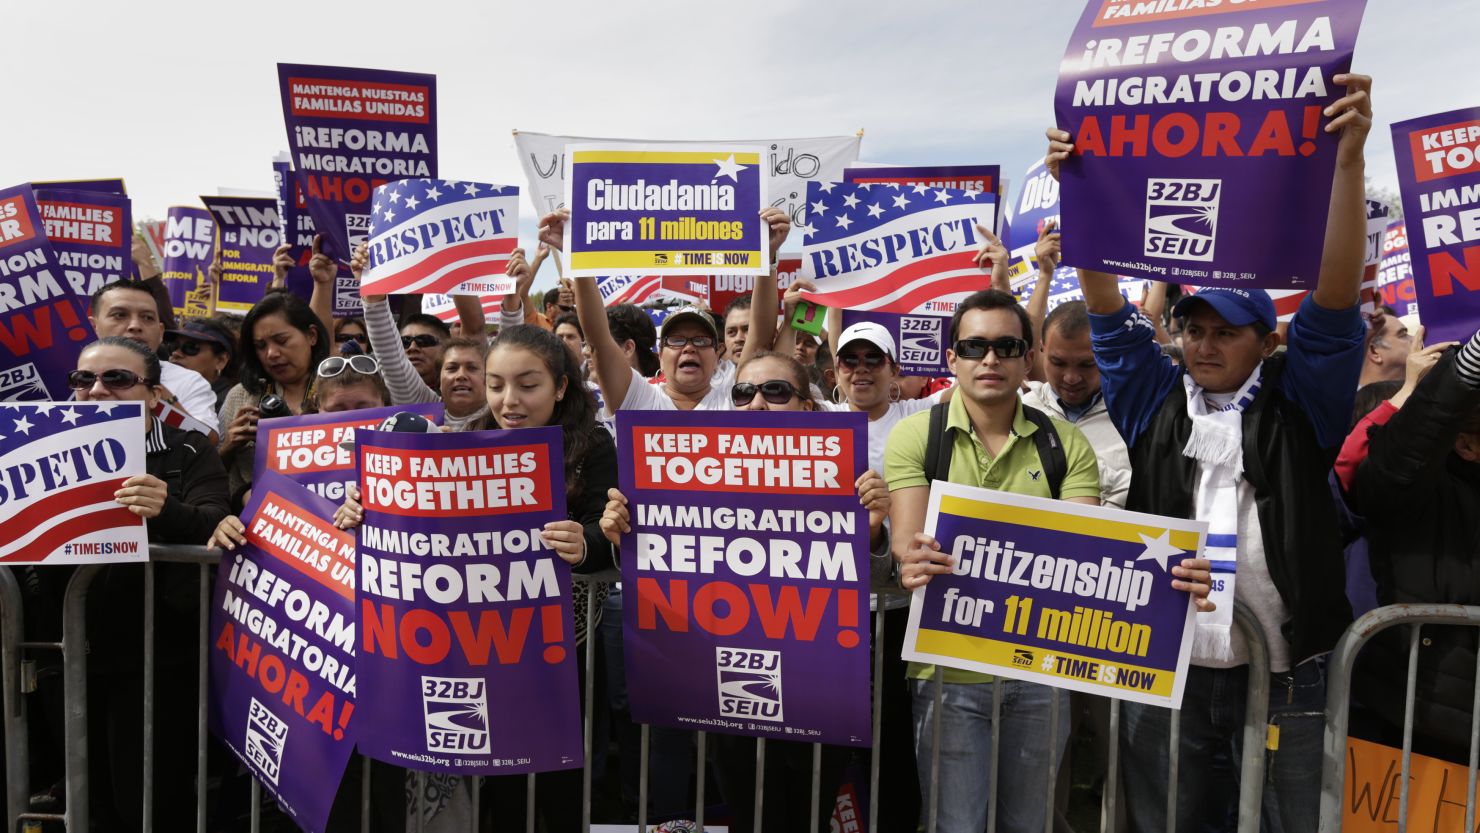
[[617, 411, 872, 746]]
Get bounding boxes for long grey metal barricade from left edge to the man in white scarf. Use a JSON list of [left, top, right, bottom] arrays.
[[0, 546, 1272, 833]]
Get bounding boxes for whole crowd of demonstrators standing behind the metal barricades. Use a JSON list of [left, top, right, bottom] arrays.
[[11, 75, 1480, 833]]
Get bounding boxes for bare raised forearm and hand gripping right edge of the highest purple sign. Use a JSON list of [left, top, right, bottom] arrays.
[[1313, 74, 1372, 309]]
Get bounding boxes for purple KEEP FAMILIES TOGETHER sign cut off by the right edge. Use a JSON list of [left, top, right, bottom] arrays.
[[1393, 108, 1480, 345]]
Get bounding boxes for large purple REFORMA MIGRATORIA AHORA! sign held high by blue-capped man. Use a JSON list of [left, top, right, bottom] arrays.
[[1055, 0, 1366, 290]]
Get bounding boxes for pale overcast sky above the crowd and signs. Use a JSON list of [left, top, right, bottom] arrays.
[[0, 0, 1480, 283]]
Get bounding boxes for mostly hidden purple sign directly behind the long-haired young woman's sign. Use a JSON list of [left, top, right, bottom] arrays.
[[252, 402, 443, 503]]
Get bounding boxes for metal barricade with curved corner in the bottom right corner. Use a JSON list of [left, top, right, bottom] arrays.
[[1320, 604, 1480, 833]]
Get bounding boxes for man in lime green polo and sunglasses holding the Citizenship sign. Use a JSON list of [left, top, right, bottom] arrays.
[[884, 290, 1100, 833]]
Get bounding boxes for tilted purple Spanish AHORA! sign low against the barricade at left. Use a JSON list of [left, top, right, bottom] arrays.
[[207, 472, 358, 833]]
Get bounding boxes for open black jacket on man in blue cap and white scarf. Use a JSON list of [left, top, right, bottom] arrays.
[[1125, 357, 1351, 661]]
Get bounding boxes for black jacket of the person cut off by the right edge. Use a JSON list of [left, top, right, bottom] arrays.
[[1351, 349, 1480, 759]]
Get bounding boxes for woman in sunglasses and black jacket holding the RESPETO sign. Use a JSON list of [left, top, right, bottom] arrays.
[[66, 336, 228, 830]]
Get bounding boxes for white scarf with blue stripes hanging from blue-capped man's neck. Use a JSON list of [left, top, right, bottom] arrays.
[[1183, 364, 1264, 663]]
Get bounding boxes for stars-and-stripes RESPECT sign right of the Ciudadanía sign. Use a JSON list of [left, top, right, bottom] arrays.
[[798, 182, 998, 315]]
